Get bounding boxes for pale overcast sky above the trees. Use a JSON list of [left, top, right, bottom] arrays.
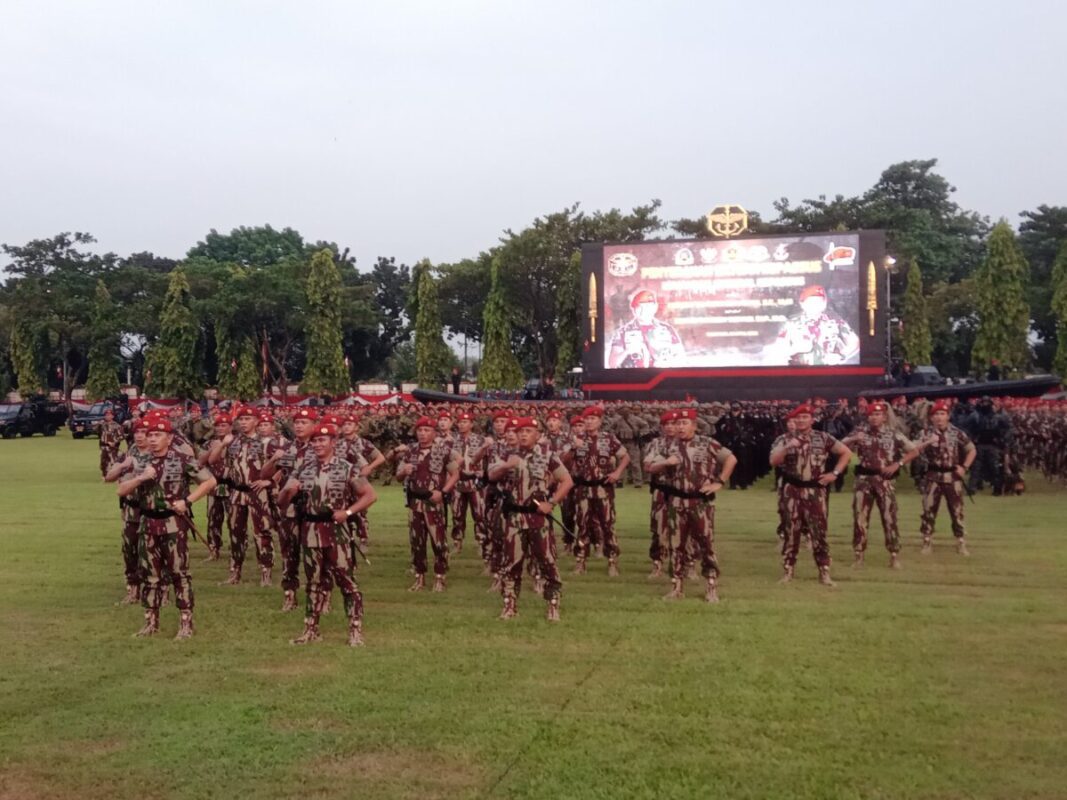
[[0, 0, 1067, 269]]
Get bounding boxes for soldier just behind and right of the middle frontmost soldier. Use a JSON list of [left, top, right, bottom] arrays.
[[568, 405, 630, 577]]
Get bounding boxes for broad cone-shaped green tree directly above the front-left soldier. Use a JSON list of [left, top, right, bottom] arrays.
[[145, 267, 204, 399]]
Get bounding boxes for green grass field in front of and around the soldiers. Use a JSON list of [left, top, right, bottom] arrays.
[[0, 435, 1067, 800]]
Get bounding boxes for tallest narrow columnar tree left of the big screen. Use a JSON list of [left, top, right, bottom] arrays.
[[301, 250, 350, 395]]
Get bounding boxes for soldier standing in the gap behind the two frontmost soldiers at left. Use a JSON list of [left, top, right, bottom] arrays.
[[208, 405, 283, 587]]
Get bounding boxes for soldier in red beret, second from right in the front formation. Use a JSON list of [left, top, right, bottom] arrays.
[[842, 402, 919, 570]]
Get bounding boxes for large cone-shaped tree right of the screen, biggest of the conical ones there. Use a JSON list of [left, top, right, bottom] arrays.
[[971, 220, 1030, 373]]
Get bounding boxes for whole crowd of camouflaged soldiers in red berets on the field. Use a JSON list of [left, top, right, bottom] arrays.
[[99, 398, 1067, 645]]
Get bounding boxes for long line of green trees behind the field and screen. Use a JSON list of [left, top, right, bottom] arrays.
[[0, 159, 1067, 398]]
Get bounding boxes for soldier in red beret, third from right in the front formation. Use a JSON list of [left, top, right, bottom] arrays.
[[770, 403, 853, 587]]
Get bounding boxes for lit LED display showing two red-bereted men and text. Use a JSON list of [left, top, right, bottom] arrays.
[[598, 234, 860, 369]]
